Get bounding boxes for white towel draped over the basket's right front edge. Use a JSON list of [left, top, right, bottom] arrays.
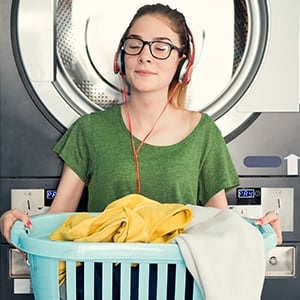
[[175, 205, 265, 300]]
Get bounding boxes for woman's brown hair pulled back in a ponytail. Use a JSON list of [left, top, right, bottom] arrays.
[[123, 3, 191, 108]]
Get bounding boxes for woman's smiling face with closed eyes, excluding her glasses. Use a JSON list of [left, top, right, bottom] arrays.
[[124, 15, 182, 93]]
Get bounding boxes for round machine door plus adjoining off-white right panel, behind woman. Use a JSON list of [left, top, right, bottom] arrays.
[[14, 0, 299, 140]]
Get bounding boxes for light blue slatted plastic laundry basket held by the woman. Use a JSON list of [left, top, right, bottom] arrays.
[[11, 213, 276, 300]]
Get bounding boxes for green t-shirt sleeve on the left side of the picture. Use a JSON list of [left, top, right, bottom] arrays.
[[53, 118, 89, 183]]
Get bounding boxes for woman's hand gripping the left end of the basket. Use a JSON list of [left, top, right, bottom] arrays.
[[0, 208, 32, 243]]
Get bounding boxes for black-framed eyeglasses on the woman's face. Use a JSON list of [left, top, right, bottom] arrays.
[[122, 37, 182, 59]]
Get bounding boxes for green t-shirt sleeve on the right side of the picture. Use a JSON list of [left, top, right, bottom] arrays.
[[199, 119, 239, 205]]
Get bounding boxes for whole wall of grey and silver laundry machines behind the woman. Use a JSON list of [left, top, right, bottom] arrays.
[[0, 0, 300, 300]]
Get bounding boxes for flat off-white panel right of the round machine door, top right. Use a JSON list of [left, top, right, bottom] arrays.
[[237, 0, 300, 112]]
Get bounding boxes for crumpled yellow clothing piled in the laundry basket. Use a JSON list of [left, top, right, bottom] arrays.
[[49, 194, 193, 284]]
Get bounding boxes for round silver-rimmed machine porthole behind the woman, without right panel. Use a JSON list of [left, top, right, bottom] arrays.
[[16, 0, 268, 138]]
